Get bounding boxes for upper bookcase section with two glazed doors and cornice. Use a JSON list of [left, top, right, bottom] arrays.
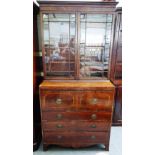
[[40, 1, 116, 79]]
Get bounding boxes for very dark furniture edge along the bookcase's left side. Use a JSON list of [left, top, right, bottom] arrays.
[[33, 3, 41, 151]]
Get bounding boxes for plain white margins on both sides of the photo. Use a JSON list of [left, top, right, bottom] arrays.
[[0, 0, 155, 155]]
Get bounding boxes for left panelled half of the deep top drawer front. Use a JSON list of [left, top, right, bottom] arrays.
[[41, 91, 75, 111]]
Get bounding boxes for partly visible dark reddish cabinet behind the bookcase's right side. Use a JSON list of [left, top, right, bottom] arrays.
[[110, 8, 122, 125]]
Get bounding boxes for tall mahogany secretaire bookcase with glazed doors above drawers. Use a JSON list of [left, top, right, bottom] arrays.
[[38, 0, 117, 150]]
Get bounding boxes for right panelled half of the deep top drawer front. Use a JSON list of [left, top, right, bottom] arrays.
[[78, 91, 114, 112]]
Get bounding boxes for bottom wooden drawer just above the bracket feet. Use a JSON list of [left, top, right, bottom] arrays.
[[43, 132, 109, 143]]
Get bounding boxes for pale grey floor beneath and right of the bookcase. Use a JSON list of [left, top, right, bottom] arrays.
[[33, 127, 122, 155]]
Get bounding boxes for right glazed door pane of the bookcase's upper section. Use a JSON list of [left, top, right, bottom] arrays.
[[80, 14, 112, 78]]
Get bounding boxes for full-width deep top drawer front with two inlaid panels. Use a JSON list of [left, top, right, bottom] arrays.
[[41, 91, 114, 112]]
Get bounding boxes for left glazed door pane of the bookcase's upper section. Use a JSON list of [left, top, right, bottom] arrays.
[[43, 14, 76, 77]]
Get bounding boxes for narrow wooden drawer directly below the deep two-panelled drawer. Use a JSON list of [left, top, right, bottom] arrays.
[[42, 111, 112, 121]]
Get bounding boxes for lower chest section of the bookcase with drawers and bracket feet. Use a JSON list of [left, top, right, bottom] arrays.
[[40, 82, 114, 150]]
